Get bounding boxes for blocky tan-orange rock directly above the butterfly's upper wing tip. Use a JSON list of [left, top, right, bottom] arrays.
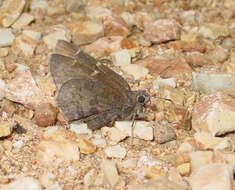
[[67, 21, 104, 45]]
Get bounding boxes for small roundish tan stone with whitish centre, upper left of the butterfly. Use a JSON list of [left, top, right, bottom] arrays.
[[12, 35, 36, 57]]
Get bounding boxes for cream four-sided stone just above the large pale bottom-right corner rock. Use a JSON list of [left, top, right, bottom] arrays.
[[189, 151, 213, 172]]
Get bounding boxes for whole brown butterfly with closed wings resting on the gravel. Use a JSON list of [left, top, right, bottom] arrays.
[[50, 40, 150, 129]]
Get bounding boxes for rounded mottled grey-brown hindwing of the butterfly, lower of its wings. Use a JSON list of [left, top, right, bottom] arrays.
[[56, 78, 125, 124]]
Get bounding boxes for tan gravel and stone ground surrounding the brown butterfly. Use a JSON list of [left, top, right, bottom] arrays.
[[0, 0, 235, 190]]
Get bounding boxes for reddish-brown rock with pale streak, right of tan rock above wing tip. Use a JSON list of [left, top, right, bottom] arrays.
[[103, 15, 130, 36]]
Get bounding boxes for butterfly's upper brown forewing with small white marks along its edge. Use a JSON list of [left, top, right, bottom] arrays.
[[50, 40, 130, 95]]
